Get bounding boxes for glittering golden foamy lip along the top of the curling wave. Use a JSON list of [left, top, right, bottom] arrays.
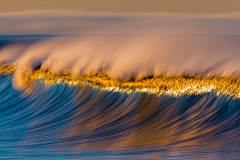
[[0, 66, 240, 98]]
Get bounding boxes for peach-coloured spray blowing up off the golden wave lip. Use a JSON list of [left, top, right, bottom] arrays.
[[0, 36, 240, 79]]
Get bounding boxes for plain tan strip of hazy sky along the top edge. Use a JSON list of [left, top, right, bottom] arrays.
[[0, 0, 240, 13]]
